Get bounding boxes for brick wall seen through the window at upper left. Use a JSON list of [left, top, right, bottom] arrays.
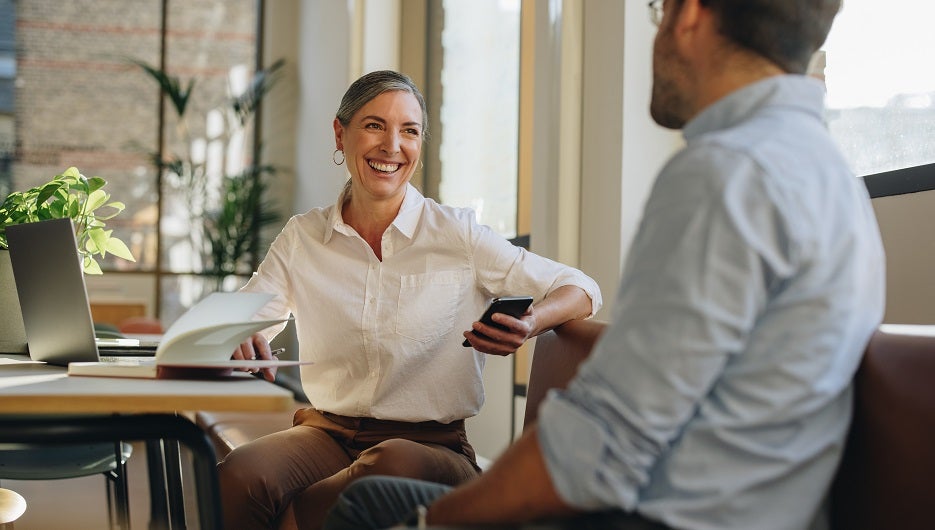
[[11, 0, 256, 270]]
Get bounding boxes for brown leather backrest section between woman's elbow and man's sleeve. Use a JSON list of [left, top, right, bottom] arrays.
[[523, 320, 606, 428]]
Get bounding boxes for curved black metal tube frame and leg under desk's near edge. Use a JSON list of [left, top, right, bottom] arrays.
[[0, 414, 223, 530]]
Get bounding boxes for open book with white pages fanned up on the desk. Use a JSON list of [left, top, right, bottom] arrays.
[[68, 292, 306, 379]]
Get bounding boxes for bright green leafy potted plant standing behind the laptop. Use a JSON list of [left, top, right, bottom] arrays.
[[0, 167, 136, 353]]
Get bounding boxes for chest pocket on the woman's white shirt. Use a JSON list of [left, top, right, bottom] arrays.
[[396, 270, 466, 342]]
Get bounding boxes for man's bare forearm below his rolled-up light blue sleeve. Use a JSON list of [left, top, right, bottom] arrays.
[[427, 426, 578, 524]]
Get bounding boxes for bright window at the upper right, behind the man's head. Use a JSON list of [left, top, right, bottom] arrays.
[[823, 0, 935, 176]]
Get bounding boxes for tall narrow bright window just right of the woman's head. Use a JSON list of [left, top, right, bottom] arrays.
[[426, 0, 520, 238]]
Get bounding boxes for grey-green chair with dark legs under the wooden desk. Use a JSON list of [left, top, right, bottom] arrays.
[[0, 442, 133, 529]]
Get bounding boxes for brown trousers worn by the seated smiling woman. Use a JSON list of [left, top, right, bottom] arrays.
[[218, 408, 480, 530]]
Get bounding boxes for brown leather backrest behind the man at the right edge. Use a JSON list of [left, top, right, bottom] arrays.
[[830, 331, 935, 530]]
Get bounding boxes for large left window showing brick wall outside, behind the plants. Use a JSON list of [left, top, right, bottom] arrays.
[[7, 0, 262, 322]]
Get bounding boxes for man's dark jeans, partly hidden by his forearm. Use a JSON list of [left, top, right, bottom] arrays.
[[323, 476, 669, 530]]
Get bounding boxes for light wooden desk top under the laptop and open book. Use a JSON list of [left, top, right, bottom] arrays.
[[0, 359, 294, 414]]
